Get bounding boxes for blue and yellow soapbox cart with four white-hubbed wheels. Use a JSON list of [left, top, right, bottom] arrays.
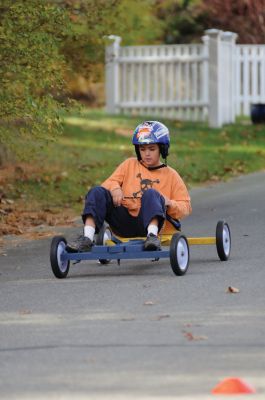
[[50, 215, 231, 278]]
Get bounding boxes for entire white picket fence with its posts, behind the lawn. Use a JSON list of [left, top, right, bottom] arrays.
[[106, 29, 265, 127]]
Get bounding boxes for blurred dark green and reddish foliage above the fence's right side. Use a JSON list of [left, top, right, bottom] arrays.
[[155, 0, 265, 44]]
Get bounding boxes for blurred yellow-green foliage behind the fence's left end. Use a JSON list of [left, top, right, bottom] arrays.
[[61, 0, 160, 81]]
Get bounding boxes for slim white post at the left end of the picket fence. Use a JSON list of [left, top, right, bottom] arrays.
[[105, 35, 121, 114]]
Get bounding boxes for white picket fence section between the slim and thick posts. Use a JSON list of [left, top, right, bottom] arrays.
[[115, 45, 208, 119]]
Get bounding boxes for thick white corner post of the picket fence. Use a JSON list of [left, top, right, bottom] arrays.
[[205, 29, 237, 128]]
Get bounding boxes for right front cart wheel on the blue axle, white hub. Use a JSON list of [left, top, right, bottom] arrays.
[[169, 233, 190, 276]]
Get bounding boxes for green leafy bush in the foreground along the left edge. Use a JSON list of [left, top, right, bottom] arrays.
[[0, 0, 69, 161]]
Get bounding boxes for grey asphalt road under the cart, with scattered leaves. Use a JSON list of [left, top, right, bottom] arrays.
[[0, 173, 265, 399]]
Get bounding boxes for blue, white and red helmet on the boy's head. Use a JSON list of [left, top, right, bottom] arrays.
[[132, 121, 170, 161]]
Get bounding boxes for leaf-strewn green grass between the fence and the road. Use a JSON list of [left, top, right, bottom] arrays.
[[5, 106, 265, 213]]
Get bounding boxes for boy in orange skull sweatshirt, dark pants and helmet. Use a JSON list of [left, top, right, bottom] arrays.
[[66, 121, 191, 252]]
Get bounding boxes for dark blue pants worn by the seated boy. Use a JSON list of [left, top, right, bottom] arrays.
[[82, 186, 166, 237]]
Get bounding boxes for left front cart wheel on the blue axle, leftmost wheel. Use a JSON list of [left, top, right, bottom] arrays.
[[50, 236, 70, 279]]
